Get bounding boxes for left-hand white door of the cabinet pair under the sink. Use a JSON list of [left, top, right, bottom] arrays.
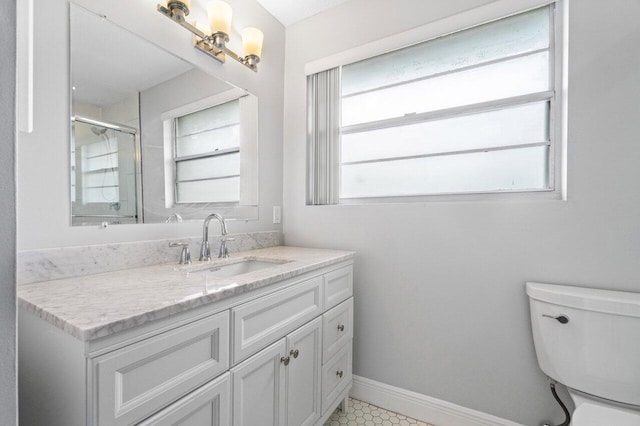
[[231, 338, 287, 426]]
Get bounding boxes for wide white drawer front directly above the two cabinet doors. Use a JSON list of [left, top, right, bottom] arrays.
[[231, 277, 322, 364]]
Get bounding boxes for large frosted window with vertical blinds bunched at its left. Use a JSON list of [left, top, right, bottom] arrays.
[[307, 5, 557, 204]]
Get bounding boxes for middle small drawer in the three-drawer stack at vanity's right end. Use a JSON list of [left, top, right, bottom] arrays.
[[322, 297, 353, 362]]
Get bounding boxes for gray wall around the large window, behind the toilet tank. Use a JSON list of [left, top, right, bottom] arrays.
[[283, 0, 640, 425]]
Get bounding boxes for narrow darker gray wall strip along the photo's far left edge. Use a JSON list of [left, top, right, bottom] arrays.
[[0, 0, 17, 426]]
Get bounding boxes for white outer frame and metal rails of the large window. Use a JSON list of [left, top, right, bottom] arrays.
[[305, 0, 566, 205]]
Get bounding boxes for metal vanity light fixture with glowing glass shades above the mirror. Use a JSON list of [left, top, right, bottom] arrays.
[[158, 0, 264, 72]]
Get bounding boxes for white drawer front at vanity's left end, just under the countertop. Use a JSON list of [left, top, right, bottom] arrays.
[[91, 311, 229, 425]]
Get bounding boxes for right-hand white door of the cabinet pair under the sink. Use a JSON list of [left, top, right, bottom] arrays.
[[285, 317, 322, 426]]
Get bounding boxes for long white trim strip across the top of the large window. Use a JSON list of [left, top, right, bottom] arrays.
[[304, 0, 555, 75]]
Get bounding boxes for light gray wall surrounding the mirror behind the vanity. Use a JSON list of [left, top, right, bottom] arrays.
[[17, 0, 285, 251]]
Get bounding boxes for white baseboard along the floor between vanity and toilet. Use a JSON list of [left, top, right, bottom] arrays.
[[350, 374, 523, 426]]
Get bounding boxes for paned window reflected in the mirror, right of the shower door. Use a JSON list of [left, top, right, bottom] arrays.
[[174, 99, 240, 203]]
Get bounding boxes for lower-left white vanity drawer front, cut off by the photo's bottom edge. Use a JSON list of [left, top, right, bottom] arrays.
[[139, 373, 231, 426]]
